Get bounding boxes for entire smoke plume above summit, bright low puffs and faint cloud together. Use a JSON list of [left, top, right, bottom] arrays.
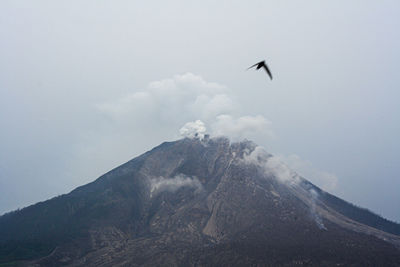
[[96, 73, 272, 144]]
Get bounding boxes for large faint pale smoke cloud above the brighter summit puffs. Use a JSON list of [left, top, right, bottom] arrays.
[[97, 73, 231, 125]]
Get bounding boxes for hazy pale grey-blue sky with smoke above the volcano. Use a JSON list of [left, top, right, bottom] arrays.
[[0, 0, 400, 222]]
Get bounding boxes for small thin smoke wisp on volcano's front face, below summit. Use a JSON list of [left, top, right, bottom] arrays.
[[150, 174, 203, 197]]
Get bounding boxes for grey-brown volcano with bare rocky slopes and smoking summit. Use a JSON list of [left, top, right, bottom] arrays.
[[0, 137, 400, 266]]
